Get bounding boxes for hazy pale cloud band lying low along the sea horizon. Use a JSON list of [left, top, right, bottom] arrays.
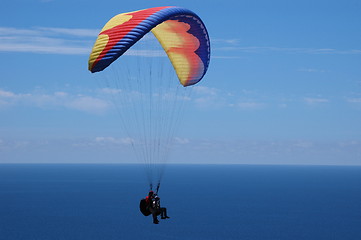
[[0, 136, 361, 165]]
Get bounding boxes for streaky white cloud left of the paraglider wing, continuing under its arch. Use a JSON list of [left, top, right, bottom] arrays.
[[0, 27, 163, 57]]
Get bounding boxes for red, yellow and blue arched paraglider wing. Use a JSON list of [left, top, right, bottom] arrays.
[[89, 7, 210, 86]]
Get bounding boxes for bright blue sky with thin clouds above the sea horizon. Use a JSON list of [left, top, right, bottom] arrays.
[[0, 0, 361, 165]]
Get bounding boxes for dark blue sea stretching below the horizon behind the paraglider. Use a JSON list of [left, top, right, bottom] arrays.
[[0, 165, 361, 240]]
